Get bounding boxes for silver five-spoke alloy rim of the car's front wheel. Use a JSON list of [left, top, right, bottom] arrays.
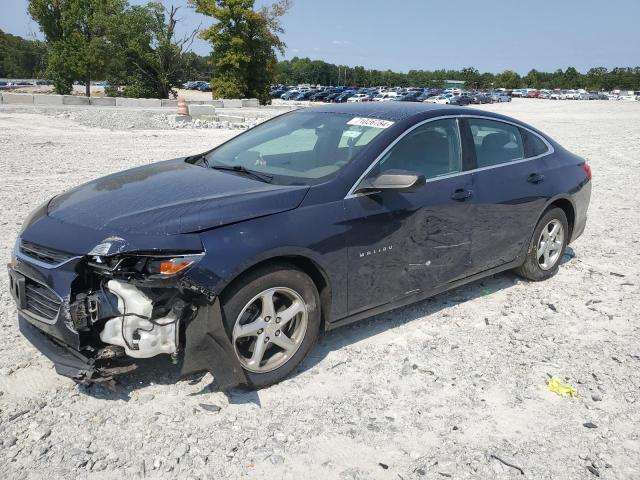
[[232, 287, 309, 373]]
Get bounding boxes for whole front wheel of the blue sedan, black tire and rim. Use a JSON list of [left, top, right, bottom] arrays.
[[221, 265, 321, 389]]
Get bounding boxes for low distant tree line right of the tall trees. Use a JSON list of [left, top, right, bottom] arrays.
[[276, 57, 640, 91]]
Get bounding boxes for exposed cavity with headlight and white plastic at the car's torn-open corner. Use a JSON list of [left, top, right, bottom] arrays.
[[69, 255, 201, 358]]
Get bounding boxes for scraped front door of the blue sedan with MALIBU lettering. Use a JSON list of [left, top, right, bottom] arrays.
[[345, 119, 472, 314]]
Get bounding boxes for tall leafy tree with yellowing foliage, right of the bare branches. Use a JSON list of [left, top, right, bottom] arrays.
[[190, 0, 290, 103]]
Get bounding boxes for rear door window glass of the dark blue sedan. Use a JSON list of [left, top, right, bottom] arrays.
[[469, 118, 525, 168]]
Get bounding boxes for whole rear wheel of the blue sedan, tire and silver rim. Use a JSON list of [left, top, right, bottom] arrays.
[[515, 207, 569, 282]]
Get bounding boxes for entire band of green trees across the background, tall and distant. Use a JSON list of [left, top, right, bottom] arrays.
[[0, 0, 640, 103]]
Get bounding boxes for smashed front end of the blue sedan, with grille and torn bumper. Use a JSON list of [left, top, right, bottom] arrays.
[[9, 241, 243, 387]]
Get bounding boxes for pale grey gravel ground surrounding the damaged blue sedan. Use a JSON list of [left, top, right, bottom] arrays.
[[0, 100, 640, 479]]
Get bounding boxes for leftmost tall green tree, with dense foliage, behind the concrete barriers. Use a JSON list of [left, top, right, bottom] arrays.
[[28, 0, 126, 96]]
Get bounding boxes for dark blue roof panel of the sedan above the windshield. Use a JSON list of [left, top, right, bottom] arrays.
[[305, 102, 505, 122]]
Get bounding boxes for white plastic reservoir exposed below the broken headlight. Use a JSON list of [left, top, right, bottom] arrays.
[[100, 280, 177, 358]]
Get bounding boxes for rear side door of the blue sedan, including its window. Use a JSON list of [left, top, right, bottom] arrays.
[[464, 117, 551, 273]]
